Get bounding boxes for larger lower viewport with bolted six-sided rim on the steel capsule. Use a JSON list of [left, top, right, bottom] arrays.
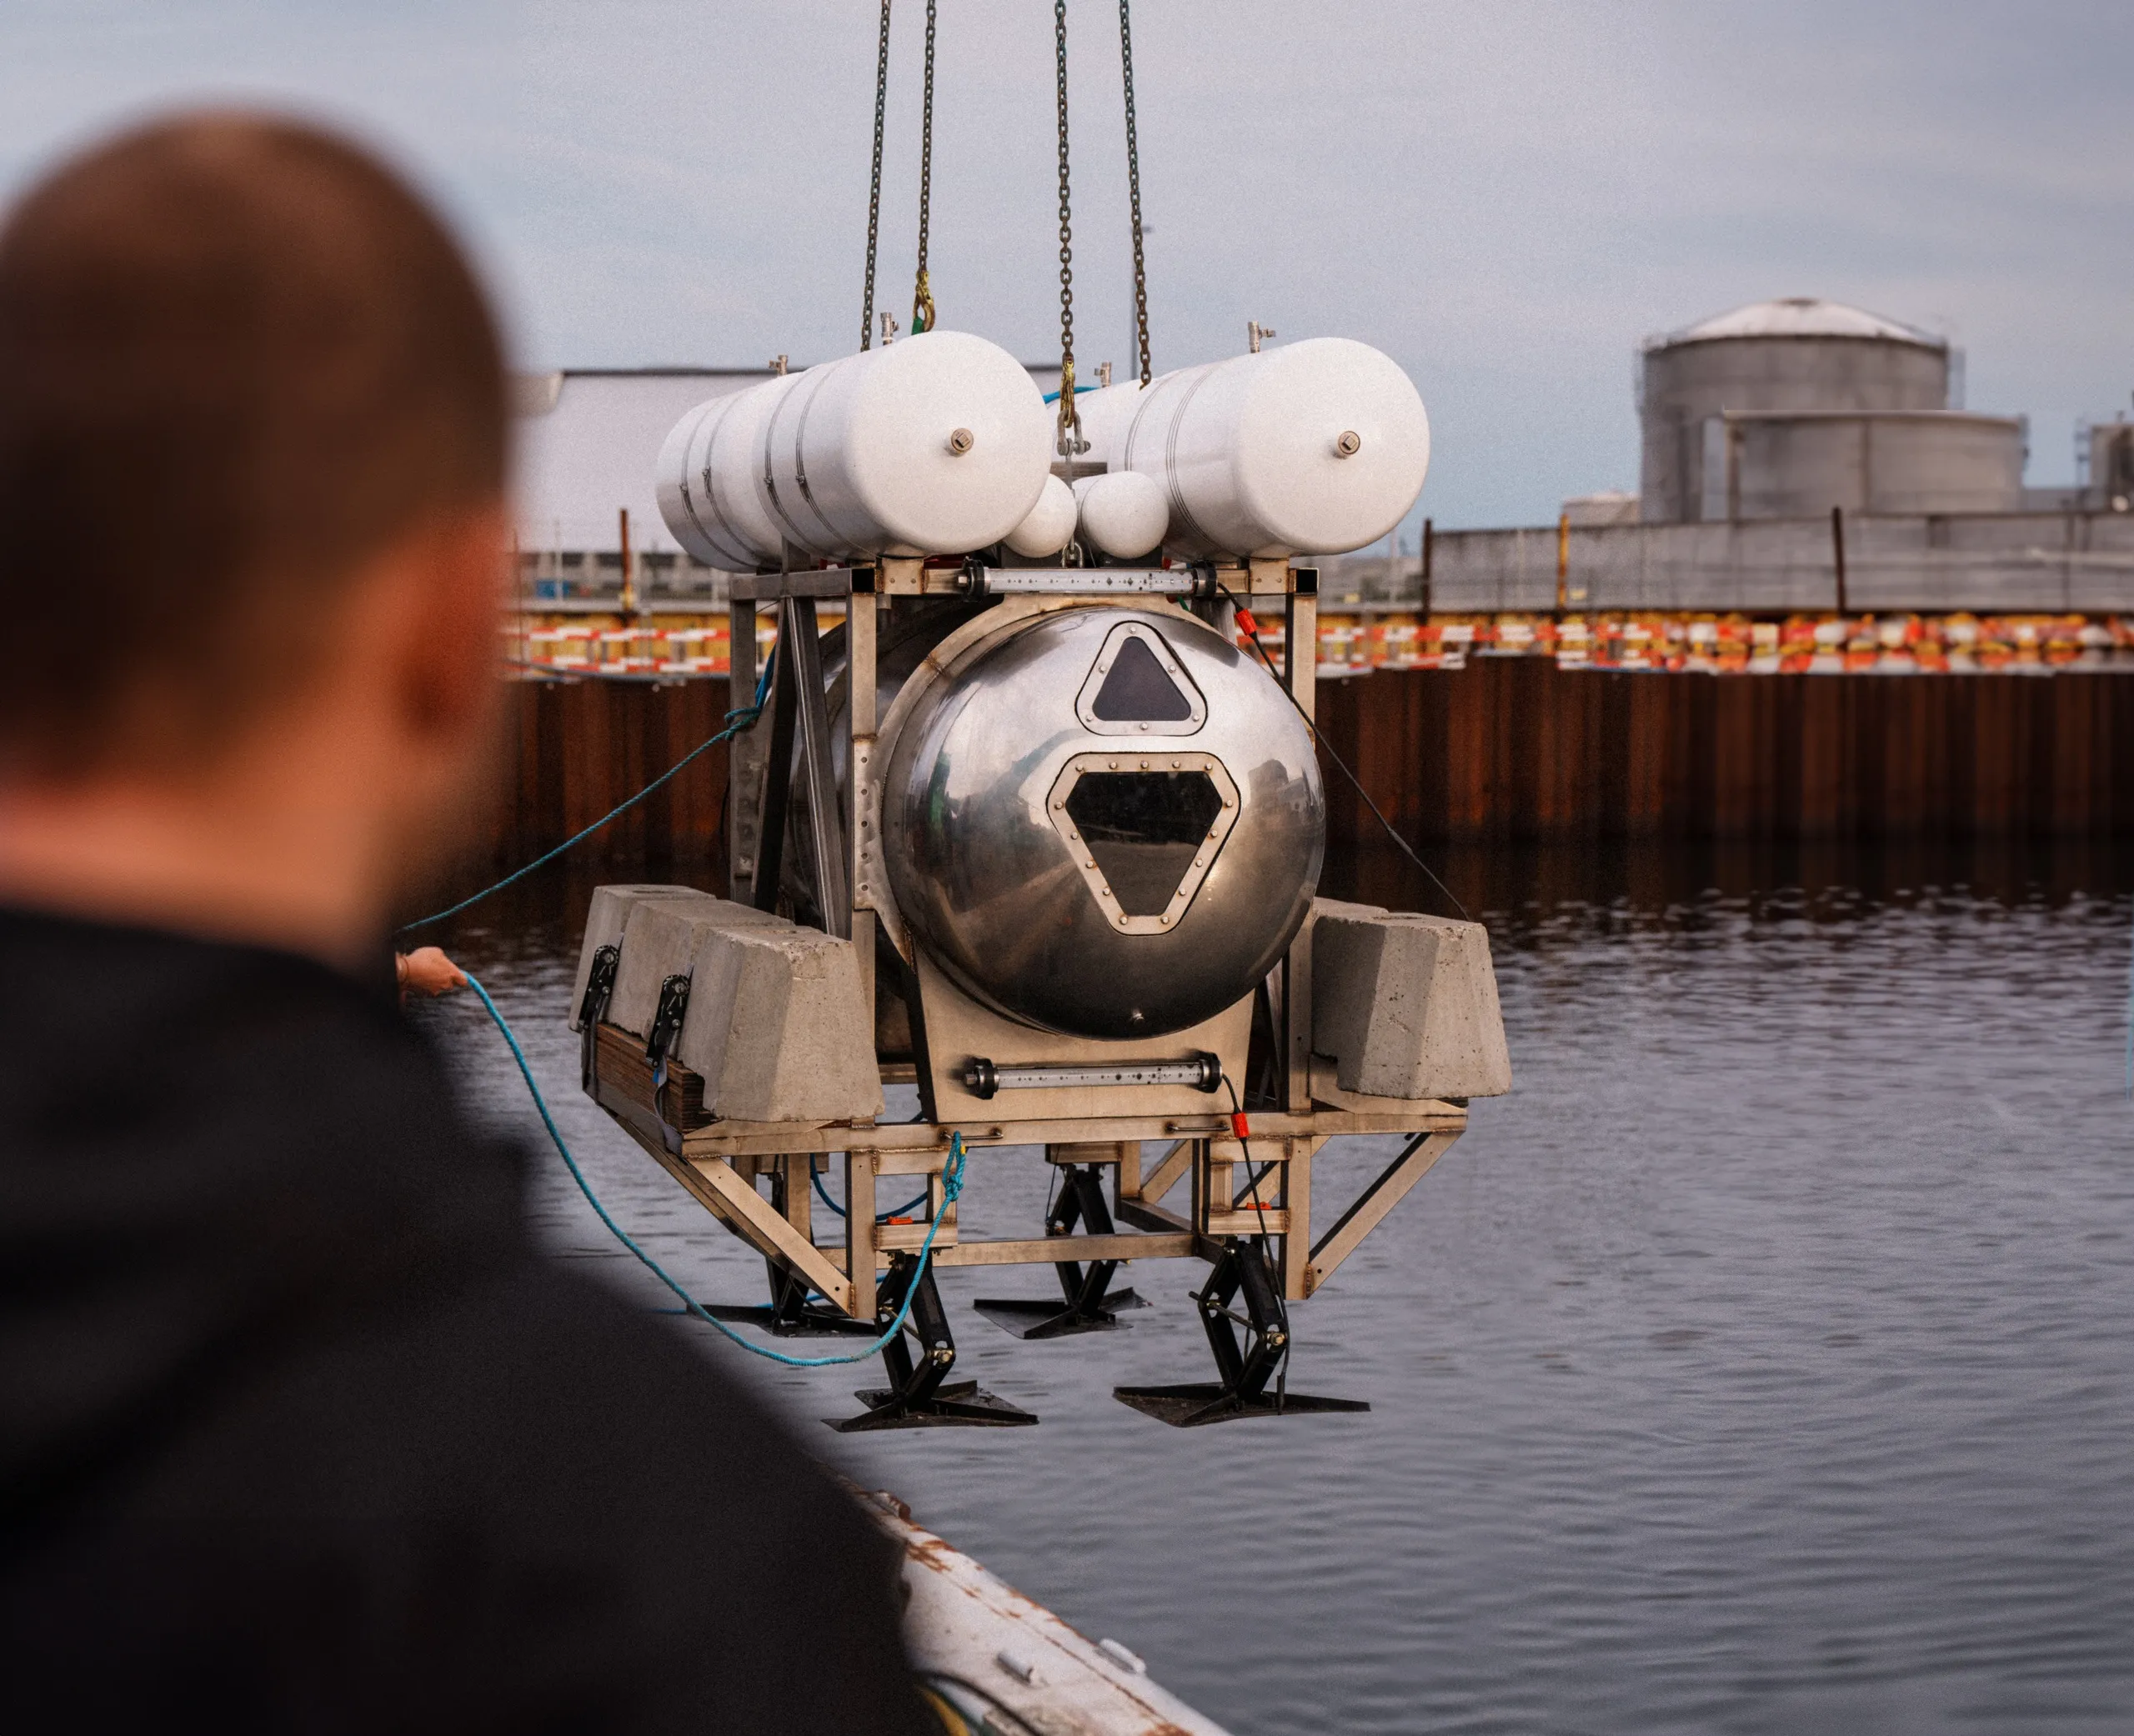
[[1050, 753, 1238, 934]]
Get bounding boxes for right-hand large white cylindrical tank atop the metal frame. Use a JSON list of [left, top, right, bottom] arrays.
[[1110, 337, 1430, 558]]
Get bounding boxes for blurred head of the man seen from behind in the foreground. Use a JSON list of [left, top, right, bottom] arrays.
[[0, 115, 506, 963]]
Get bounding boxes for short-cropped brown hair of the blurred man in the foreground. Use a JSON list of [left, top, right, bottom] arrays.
[[0, 113, 506, 776]]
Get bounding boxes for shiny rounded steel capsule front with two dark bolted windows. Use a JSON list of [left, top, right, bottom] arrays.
[[881, 606, 1325, 1038]]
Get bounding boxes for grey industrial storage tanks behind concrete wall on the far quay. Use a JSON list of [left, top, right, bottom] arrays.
[[1325, 297, 2134, 614]]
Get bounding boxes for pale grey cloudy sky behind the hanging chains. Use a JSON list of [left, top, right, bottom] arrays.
[[0, 0, 2134, 525]]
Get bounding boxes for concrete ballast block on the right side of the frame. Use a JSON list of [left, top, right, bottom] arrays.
[[1312, 898, 1510, 1098]]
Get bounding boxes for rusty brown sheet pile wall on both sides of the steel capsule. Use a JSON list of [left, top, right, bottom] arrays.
[[491, 657, 2134, 870]]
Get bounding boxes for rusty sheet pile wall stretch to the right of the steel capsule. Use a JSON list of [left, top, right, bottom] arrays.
[[1319, 657, 2134, 847]]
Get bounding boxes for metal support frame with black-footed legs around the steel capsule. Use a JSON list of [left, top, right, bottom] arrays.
[[584, 558, 1466, 1427]]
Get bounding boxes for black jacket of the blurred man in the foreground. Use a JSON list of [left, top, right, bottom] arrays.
[[0, 911, 930, 1736]]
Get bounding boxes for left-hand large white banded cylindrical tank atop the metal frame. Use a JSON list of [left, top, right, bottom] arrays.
[[659, 331, 1052, 569]]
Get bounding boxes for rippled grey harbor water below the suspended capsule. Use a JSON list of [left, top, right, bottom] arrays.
[[418, 847, 2134, 1736]]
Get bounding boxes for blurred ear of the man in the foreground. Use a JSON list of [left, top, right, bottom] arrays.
[[399, 501, 510, 747]]
